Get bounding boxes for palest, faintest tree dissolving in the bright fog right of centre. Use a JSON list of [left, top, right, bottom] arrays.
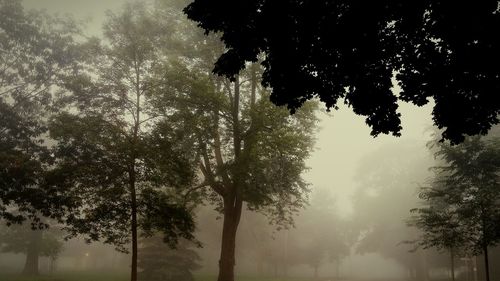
[[353, 143, 433, 280]]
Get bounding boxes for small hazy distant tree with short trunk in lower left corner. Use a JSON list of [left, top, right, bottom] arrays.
[[0, 222, 63, 275]]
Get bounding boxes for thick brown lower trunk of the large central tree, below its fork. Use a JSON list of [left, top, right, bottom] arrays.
[[217, 196, 242, 281]]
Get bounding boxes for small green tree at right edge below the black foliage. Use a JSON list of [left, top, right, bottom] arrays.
[[418, 137, 500, 281]]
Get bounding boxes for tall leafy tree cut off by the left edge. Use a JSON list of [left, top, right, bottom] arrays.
[[0, 0, 81, 227]]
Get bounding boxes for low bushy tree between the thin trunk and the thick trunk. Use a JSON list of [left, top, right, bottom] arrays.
[[138, 236, 200, 281]]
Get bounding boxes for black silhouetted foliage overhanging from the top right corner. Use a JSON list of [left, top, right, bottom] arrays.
[[184, 0, 500, 143]]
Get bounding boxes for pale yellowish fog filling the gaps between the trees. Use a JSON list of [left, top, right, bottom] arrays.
[[0, 0, 500, 281]]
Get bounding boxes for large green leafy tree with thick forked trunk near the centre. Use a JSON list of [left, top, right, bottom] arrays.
[[157, 34, 316, 281]]
